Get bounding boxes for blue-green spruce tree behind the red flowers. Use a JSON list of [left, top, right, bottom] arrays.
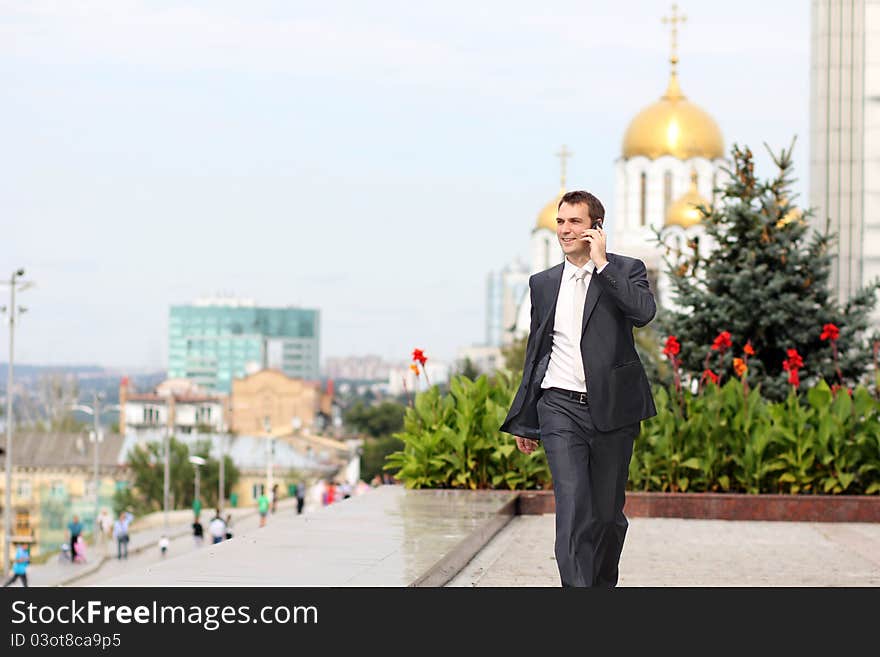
[[655, 142, 880, 400]]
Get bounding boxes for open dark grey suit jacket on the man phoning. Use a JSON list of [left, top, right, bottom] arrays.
[[501, 253, 657, 440]]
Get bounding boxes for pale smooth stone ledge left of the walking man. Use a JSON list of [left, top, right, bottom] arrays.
[[93, 486, 516, 587]]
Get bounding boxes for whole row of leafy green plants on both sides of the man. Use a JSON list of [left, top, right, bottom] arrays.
[[385, 372, 880, 495]]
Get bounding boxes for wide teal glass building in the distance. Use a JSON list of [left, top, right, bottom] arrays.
[[168, 299, 320, 393]]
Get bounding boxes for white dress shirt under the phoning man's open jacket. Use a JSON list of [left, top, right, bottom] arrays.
[[541, 258, 608, 392]]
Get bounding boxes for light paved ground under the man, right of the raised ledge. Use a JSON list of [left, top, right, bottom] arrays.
[[448, 515, 880, 587]]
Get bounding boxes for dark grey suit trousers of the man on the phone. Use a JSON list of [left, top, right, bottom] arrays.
[[537, 388, 641, 587]]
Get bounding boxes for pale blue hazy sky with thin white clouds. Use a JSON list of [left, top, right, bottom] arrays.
[[0, 0, 810, 369]]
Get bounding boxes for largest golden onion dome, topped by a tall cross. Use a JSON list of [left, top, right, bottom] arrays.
[[623, 70, 724, 160]]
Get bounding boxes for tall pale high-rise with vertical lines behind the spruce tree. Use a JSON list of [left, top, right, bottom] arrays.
[[810, 0, 880, 328]]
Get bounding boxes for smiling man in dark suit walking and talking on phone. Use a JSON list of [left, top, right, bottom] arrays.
[[501, 191, 657, 587]]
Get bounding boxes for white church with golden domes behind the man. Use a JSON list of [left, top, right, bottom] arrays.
[[514, 17, 730, 337]]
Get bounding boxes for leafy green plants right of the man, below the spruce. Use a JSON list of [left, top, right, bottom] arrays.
[[630, 379, 880, 494]]
